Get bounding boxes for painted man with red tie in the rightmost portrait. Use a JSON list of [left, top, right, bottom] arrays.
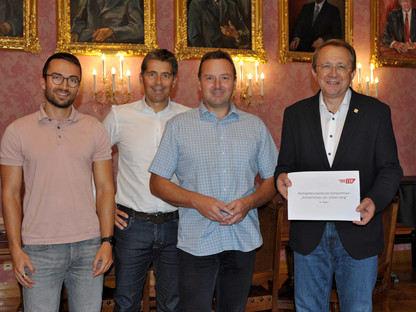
[[382, 0, 416, 53]]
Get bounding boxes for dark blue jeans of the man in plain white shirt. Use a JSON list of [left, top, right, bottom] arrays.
[[114, 214, 179, 312]]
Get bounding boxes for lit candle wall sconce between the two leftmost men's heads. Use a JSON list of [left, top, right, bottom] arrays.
[[92, 54, 133, 105]]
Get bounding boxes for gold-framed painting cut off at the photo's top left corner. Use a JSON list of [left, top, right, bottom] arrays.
[[0, 0, 41, 53]]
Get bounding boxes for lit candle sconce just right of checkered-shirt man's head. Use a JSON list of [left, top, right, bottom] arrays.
[[233, 60, 264, 108]]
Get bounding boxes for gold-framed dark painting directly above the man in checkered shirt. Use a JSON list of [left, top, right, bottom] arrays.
[[175, 0, 267, 63]]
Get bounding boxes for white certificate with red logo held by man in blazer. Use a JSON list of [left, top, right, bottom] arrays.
[[288, 171, 360, 221]]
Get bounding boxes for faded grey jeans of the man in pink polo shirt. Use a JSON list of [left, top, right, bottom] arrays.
[[22, 237, 103, 312]]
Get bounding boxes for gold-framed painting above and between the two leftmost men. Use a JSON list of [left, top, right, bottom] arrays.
[[57, 0, 158, 55]]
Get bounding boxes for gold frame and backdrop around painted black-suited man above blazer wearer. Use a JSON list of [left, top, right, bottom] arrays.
[[279, 0, 353, 63]]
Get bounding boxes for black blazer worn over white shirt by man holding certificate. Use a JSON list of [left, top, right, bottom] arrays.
[[275, 91, 403, 259]]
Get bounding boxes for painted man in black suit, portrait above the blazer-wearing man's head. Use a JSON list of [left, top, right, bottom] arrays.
[[289, 0, 343, 52]]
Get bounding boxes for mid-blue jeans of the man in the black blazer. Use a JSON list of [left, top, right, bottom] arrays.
[[295, 222, 378, 312]]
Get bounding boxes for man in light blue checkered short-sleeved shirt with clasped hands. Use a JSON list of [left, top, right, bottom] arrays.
[[149, 50, 278, 312]]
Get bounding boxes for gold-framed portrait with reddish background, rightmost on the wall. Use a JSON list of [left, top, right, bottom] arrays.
[[371, 0, 416, 67]]
